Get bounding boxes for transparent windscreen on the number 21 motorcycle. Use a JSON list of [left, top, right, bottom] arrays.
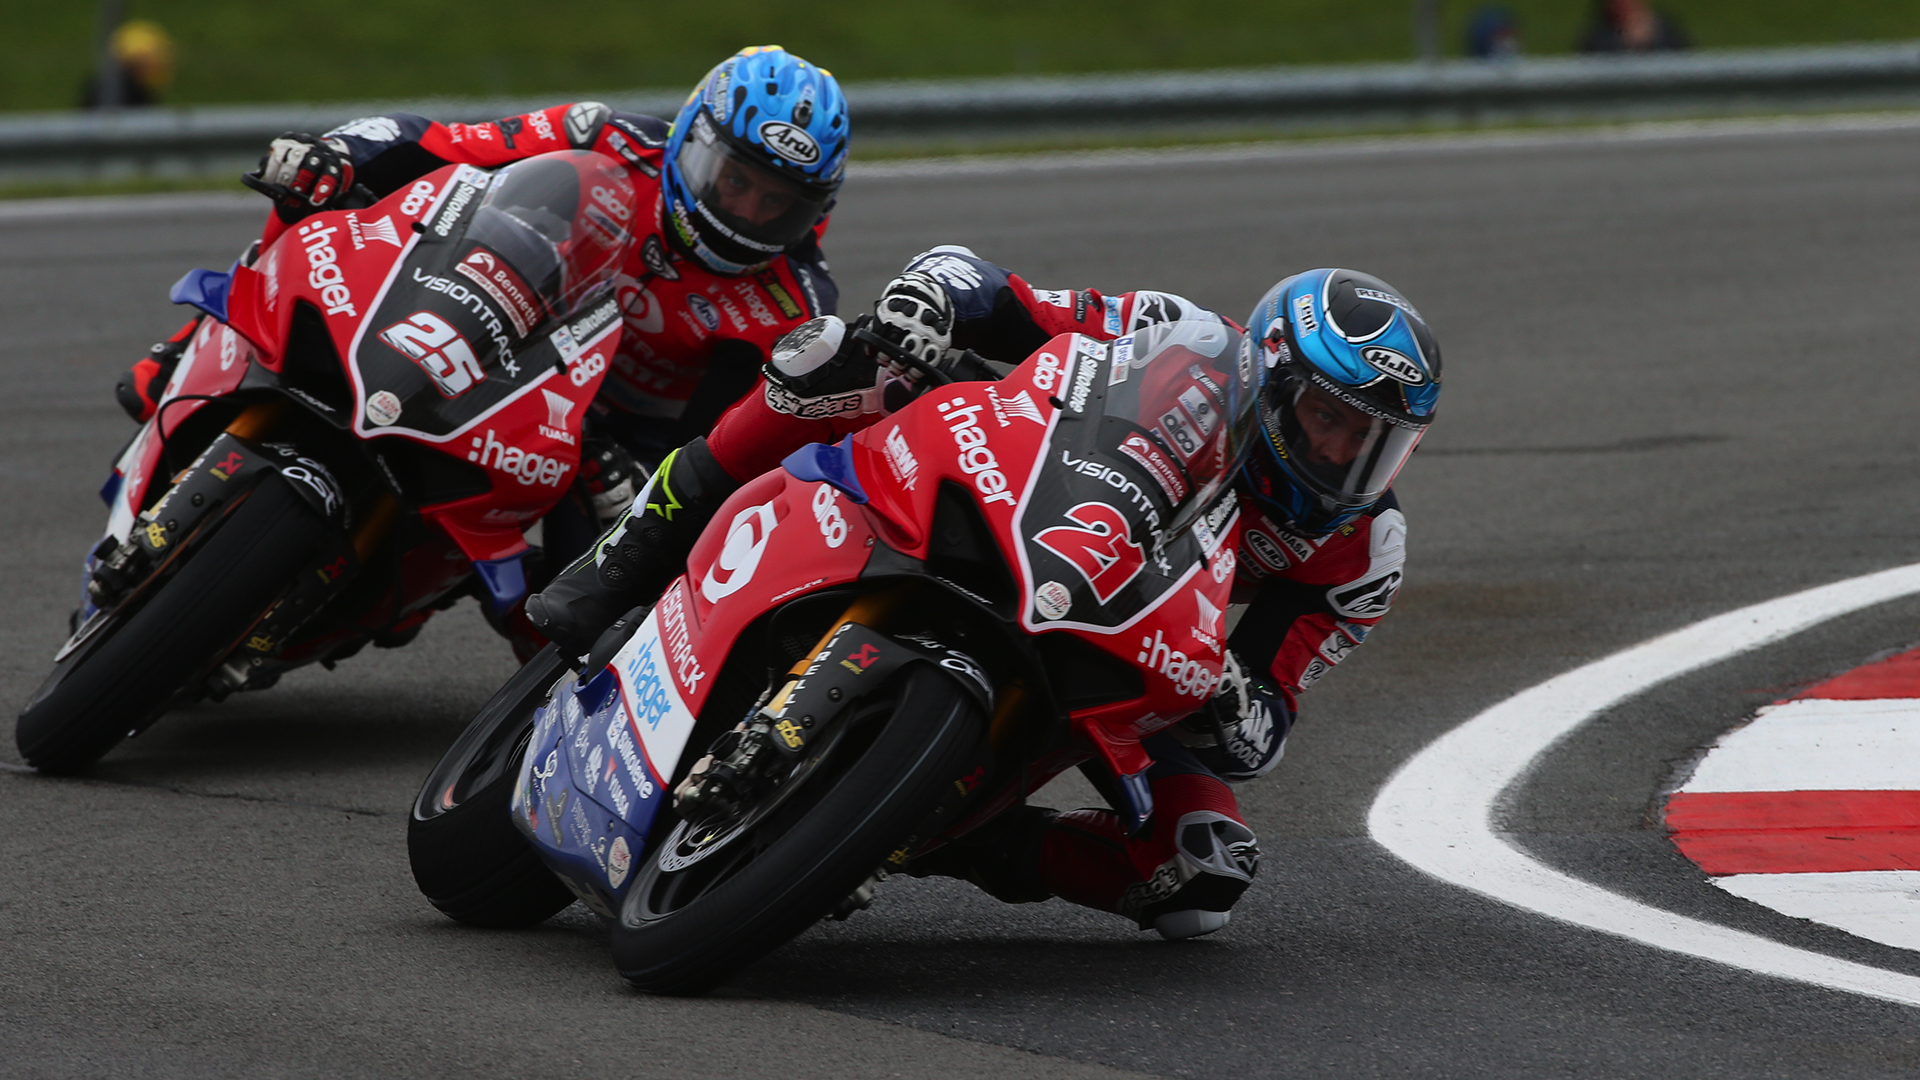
[[1102, 319, 1260, 544]]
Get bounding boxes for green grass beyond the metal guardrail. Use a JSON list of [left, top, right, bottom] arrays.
[[0, 0, 1920, 110]]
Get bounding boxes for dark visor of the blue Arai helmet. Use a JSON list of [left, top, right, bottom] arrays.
[[676, 125, 831, 258]]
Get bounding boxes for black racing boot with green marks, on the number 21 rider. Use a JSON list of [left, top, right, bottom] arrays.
[[526, 438, 739, 655]]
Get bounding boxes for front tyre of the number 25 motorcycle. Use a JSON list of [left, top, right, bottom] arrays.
[[13, 475, 324, 773]]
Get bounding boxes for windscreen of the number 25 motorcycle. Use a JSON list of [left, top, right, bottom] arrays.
[[463, 150, 636, 319]]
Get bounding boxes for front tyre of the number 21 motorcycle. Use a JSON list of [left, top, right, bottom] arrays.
[[612, 665, 987, 994]]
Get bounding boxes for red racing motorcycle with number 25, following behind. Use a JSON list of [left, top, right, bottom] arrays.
[[15, 152, 637, 773]]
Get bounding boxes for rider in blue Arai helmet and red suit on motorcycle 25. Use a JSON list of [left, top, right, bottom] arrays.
[[115, 46, 849, 572]]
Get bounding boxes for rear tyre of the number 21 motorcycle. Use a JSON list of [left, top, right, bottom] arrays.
[[407, 646, 574, 928]]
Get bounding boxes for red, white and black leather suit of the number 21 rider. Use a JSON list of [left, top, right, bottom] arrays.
[[707, 248, 1405, 928]]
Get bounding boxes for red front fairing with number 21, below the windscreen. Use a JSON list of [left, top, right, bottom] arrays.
[[852, 334, 1238, 745]]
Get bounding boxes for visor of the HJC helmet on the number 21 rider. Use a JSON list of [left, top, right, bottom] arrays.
[[1263, 369, 1427, 509]]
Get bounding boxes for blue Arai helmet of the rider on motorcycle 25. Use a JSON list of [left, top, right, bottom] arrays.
[[660, 44, 847, 275]]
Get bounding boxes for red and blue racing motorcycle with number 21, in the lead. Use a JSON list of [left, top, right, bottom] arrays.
[[409, 319, 1258, 994]]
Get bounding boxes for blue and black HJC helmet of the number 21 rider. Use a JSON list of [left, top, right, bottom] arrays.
[[1246, 269, 1440, 536]]
